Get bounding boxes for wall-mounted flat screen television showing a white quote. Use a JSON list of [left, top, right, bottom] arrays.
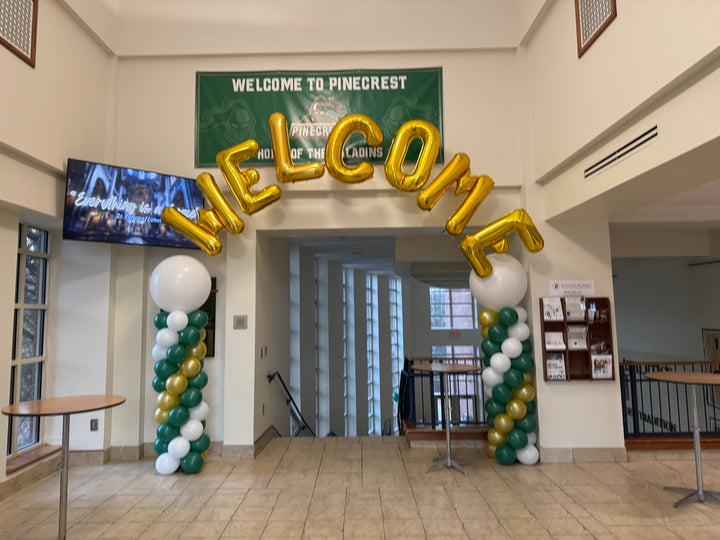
[[63, 159, 203, 249]]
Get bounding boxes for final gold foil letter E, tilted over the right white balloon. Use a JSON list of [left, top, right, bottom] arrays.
[[460, 209, 544, 277]]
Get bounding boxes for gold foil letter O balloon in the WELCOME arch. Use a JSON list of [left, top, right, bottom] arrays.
[[385, 120, 440, 191]]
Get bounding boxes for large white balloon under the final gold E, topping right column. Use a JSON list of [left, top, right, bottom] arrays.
[[470, 253, 527, 311]]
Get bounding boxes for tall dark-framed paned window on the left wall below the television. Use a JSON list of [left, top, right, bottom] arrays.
[[7, 224, 50, 456]]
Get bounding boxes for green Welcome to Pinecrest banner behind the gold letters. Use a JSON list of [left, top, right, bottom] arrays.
[[195, 68, 444, 167]]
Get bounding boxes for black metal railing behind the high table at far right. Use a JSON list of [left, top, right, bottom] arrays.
[[619, 359, 720, 438]]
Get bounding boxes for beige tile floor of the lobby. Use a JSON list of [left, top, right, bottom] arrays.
[[0, 437, 720, 540]]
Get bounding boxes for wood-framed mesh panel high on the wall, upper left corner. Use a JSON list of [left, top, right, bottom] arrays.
[[0, 0, 38, 67]]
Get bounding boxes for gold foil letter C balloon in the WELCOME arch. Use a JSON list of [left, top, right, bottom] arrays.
[[325, 114, 383, 184]]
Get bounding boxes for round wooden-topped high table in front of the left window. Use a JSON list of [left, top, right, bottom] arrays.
[[2, 394, 125, 540]]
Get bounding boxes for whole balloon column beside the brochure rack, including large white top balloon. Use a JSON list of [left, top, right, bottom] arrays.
[[470, 254, 540, 465]]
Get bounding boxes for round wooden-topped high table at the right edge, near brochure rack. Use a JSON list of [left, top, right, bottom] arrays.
[[643, 371, 720, 508]]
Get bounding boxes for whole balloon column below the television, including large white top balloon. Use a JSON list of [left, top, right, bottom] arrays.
[[150, 255, 211, 475]]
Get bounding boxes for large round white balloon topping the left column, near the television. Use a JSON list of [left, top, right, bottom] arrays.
[[150, 255, 211, 313]]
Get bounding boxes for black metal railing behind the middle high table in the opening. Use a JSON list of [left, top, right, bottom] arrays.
[[398, 357, 487, 429]]
